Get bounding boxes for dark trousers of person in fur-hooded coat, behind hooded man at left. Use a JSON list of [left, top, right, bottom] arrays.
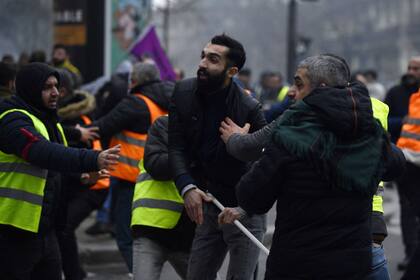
[[57, 190, 107, 280]]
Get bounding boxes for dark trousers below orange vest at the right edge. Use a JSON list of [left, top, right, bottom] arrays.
[[397, 162, 420, 280]]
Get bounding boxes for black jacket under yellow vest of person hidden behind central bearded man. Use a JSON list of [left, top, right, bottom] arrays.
[[133, 116, 195, 252]]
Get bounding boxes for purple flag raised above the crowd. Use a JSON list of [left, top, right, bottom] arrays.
[[130, 26, 176, 80]]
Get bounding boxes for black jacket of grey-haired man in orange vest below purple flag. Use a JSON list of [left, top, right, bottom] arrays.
[[92, 81, 173, 137]]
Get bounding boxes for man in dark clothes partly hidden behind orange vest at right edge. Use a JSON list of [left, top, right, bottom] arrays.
[[385, 57, 420, 270]]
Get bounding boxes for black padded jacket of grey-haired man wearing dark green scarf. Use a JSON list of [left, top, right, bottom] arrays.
[[236, 87, 404, 279]]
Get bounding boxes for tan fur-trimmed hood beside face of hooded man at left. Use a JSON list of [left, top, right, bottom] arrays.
[[57, 90, 96, 120]]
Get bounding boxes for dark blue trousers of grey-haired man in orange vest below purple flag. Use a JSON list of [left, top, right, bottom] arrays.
[[112, 179, 134, 272]]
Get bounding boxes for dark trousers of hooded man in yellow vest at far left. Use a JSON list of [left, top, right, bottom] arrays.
[[0, 231, 61, 280]]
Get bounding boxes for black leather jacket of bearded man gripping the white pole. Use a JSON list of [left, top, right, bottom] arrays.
[[169, 78, 266, 206]]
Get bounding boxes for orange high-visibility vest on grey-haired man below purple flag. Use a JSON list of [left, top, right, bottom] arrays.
[[110, 94, 168, 183]]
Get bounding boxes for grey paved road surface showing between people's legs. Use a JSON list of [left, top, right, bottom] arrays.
[[86, 185, 403, 280]]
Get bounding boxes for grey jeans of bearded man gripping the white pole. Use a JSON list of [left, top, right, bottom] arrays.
[[187, 203, 266, 280]]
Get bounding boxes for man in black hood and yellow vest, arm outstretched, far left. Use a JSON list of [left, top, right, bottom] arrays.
[[0, 63, 120, 280]]
